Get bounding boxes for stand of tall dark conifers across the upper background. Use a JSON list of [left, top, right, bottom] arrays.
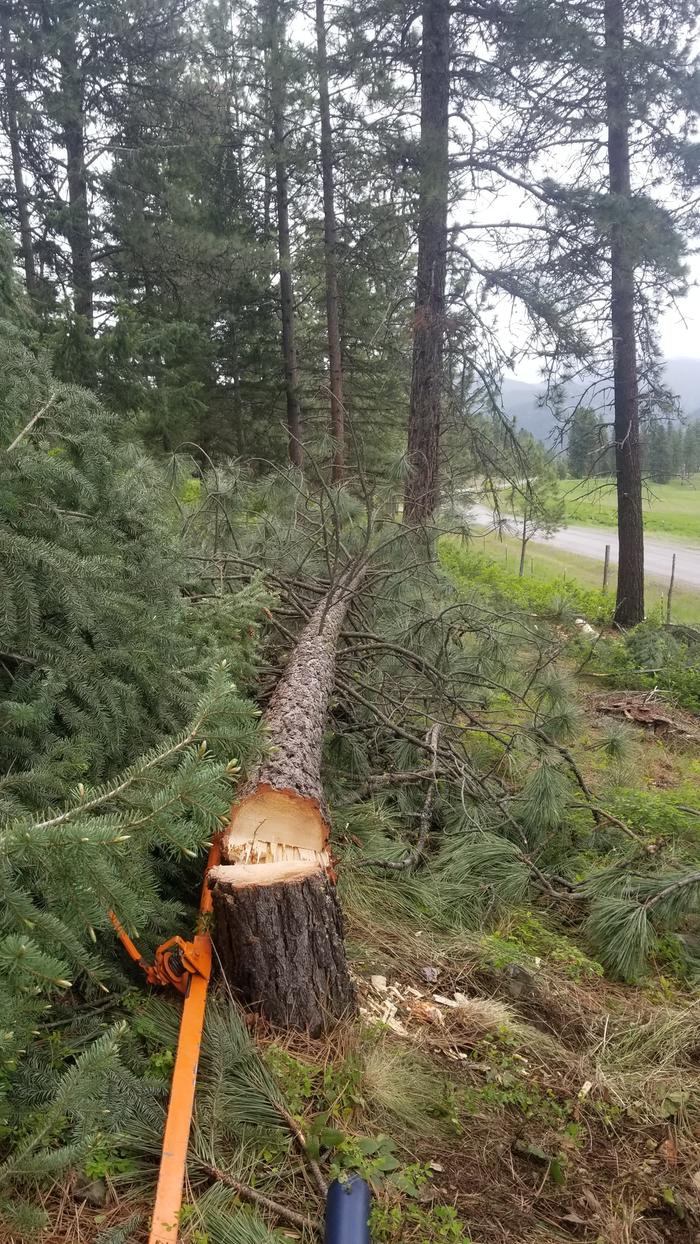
[[0, 0, 698, 623]]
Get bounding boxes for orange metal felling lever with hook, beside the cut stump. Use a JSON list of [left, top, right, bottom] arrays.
[[109, 838, 221, 1244]]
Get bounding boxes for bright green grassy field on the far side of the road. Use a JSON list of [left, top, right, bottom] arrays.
[[561, 475, 700, 541]]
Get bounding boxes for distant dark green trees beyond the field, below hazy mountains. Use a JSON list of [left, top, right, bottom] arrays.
[[566, 408, 700, 484]]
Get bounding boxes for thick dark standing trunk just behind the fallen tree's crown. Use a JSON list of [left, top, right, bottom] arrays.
[[404, 0, 450, 522]]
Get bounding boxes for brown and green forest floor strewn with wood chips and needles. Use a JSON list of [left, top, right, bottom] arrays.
[[42, 680, 700, 1244]]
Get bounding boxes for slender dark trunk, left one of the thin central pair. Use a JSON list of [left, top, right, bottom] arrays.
[[270, 0, 303, 468]]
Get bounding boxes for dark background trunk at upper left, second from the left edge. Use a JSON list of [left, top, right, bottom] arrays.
[[58, 29, 94, 332]]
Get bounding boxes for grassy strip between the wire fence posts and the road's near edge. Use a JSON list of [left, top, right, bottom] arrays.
[[472, 527, 700, 623]]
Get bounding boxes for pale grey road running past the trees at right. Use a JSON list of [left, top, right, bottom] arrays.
[[469, 505, 700, 588]]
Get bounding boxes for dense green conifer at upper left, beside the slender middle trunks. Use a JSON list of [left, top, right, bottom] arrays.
[[99, 6, 286, 462]]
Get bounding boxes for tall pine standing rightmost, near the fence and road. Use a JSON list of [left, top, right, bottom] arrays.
[[474, 0, 696, 623]]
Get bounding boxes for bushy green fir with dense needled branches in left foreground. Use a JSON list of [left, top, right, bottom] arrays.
[[0, 231, 261, 1119]]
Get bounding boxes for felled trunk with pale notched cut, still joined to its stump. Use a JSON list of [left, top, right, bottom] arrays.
[[209, 570, 362, 1035]]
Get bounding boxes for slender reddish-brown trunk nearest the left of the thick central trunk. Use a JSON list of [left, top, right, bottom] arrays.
[[316, 0, 344, 484]]
